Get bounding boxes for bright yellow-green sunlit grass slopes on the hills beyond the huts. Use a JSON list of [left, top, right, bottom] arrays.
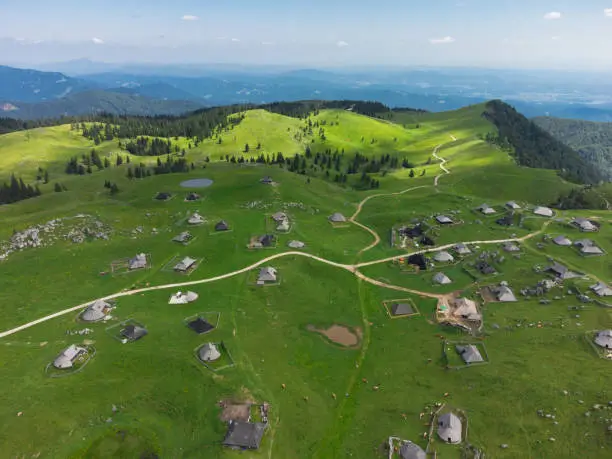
[[0, 105, 580, 203]]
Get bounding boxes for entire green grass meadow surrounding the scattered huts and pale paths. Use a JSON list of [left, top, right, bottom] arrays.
[[0, 102, 612, 459]]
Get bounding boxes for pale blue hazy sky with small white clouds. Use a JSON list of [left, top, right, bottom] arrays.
[[0, 0, 612, 70]]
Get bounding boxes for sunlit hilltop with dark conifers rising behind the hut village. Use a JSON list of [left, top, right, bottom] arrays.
[[0, 101, 592, 203]]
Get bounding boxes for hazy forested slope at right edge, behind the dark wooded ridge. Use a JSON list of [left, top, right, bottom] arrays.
[[533, 117, 612, 181]]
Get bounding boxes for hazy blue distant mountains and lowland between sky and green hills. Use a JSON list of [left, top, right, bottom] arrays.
[[0, 60, 612, 121]]
